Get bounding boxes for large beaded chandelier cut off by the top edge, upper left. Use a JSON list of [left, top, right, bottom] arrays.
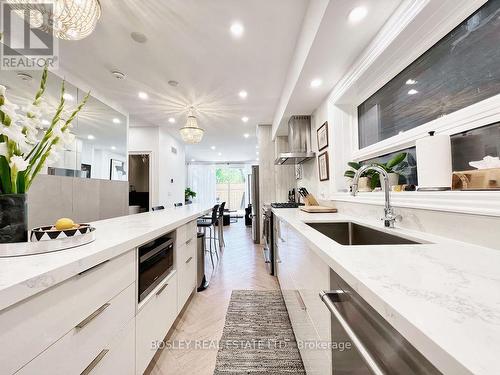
[[7, 0, 101, 40]]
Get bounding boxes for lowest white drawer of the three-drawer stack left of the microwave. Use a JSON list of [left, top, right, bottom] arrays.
[[87, 319, 135, 375]]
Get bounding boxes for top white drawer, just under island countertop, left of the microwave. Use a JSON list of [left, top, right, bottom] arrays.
[[0, 251, 136, 374]]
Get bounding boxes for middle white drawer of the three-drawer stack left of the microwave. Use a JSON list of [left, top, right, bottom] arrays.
[[18, 283, 135, 375]]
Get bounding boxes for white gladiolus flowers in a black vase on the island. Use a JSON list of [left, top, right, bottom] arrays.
[[0, 67, 90, 243]]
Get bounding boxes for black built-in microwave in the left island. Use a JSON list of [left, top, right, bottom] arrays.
[[138, 234, 174, 302]]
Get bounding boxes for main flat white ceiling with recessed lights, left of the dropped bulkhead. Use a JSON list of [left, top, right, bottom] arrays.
[[60, 0, 308, 161]]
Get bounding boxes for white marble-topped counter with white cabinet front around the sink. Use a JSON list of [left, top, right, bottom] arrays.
[[273, 209, 500, 375]]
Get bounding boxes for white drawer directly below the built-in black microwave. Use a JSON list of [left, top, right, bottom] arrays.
[[135, 273, 177, 374]]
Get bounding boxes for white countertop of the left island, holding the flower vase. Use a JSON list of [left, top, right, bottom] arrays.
[[0, 206, 210, 311]]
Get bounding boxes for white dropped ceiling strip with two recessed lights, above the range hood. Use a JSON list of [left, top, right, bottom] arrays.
[[275, 0, 402, 135]]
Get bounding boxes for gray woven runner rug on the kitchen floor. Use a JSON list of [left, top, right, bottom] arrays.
[[214, 290, 306, 375]]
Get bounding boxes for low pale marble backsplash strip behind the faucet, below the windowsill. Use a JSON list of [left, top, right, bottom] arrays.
[[321, 201, 500, 250]]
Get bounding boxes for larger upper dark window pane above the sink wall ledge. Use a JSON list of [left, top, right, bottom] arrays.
[[358, 0, 500, 148]]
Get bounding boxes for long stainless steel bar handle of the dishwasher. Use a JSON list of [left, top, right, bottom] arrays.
[[319, 290, 385, 375]]
